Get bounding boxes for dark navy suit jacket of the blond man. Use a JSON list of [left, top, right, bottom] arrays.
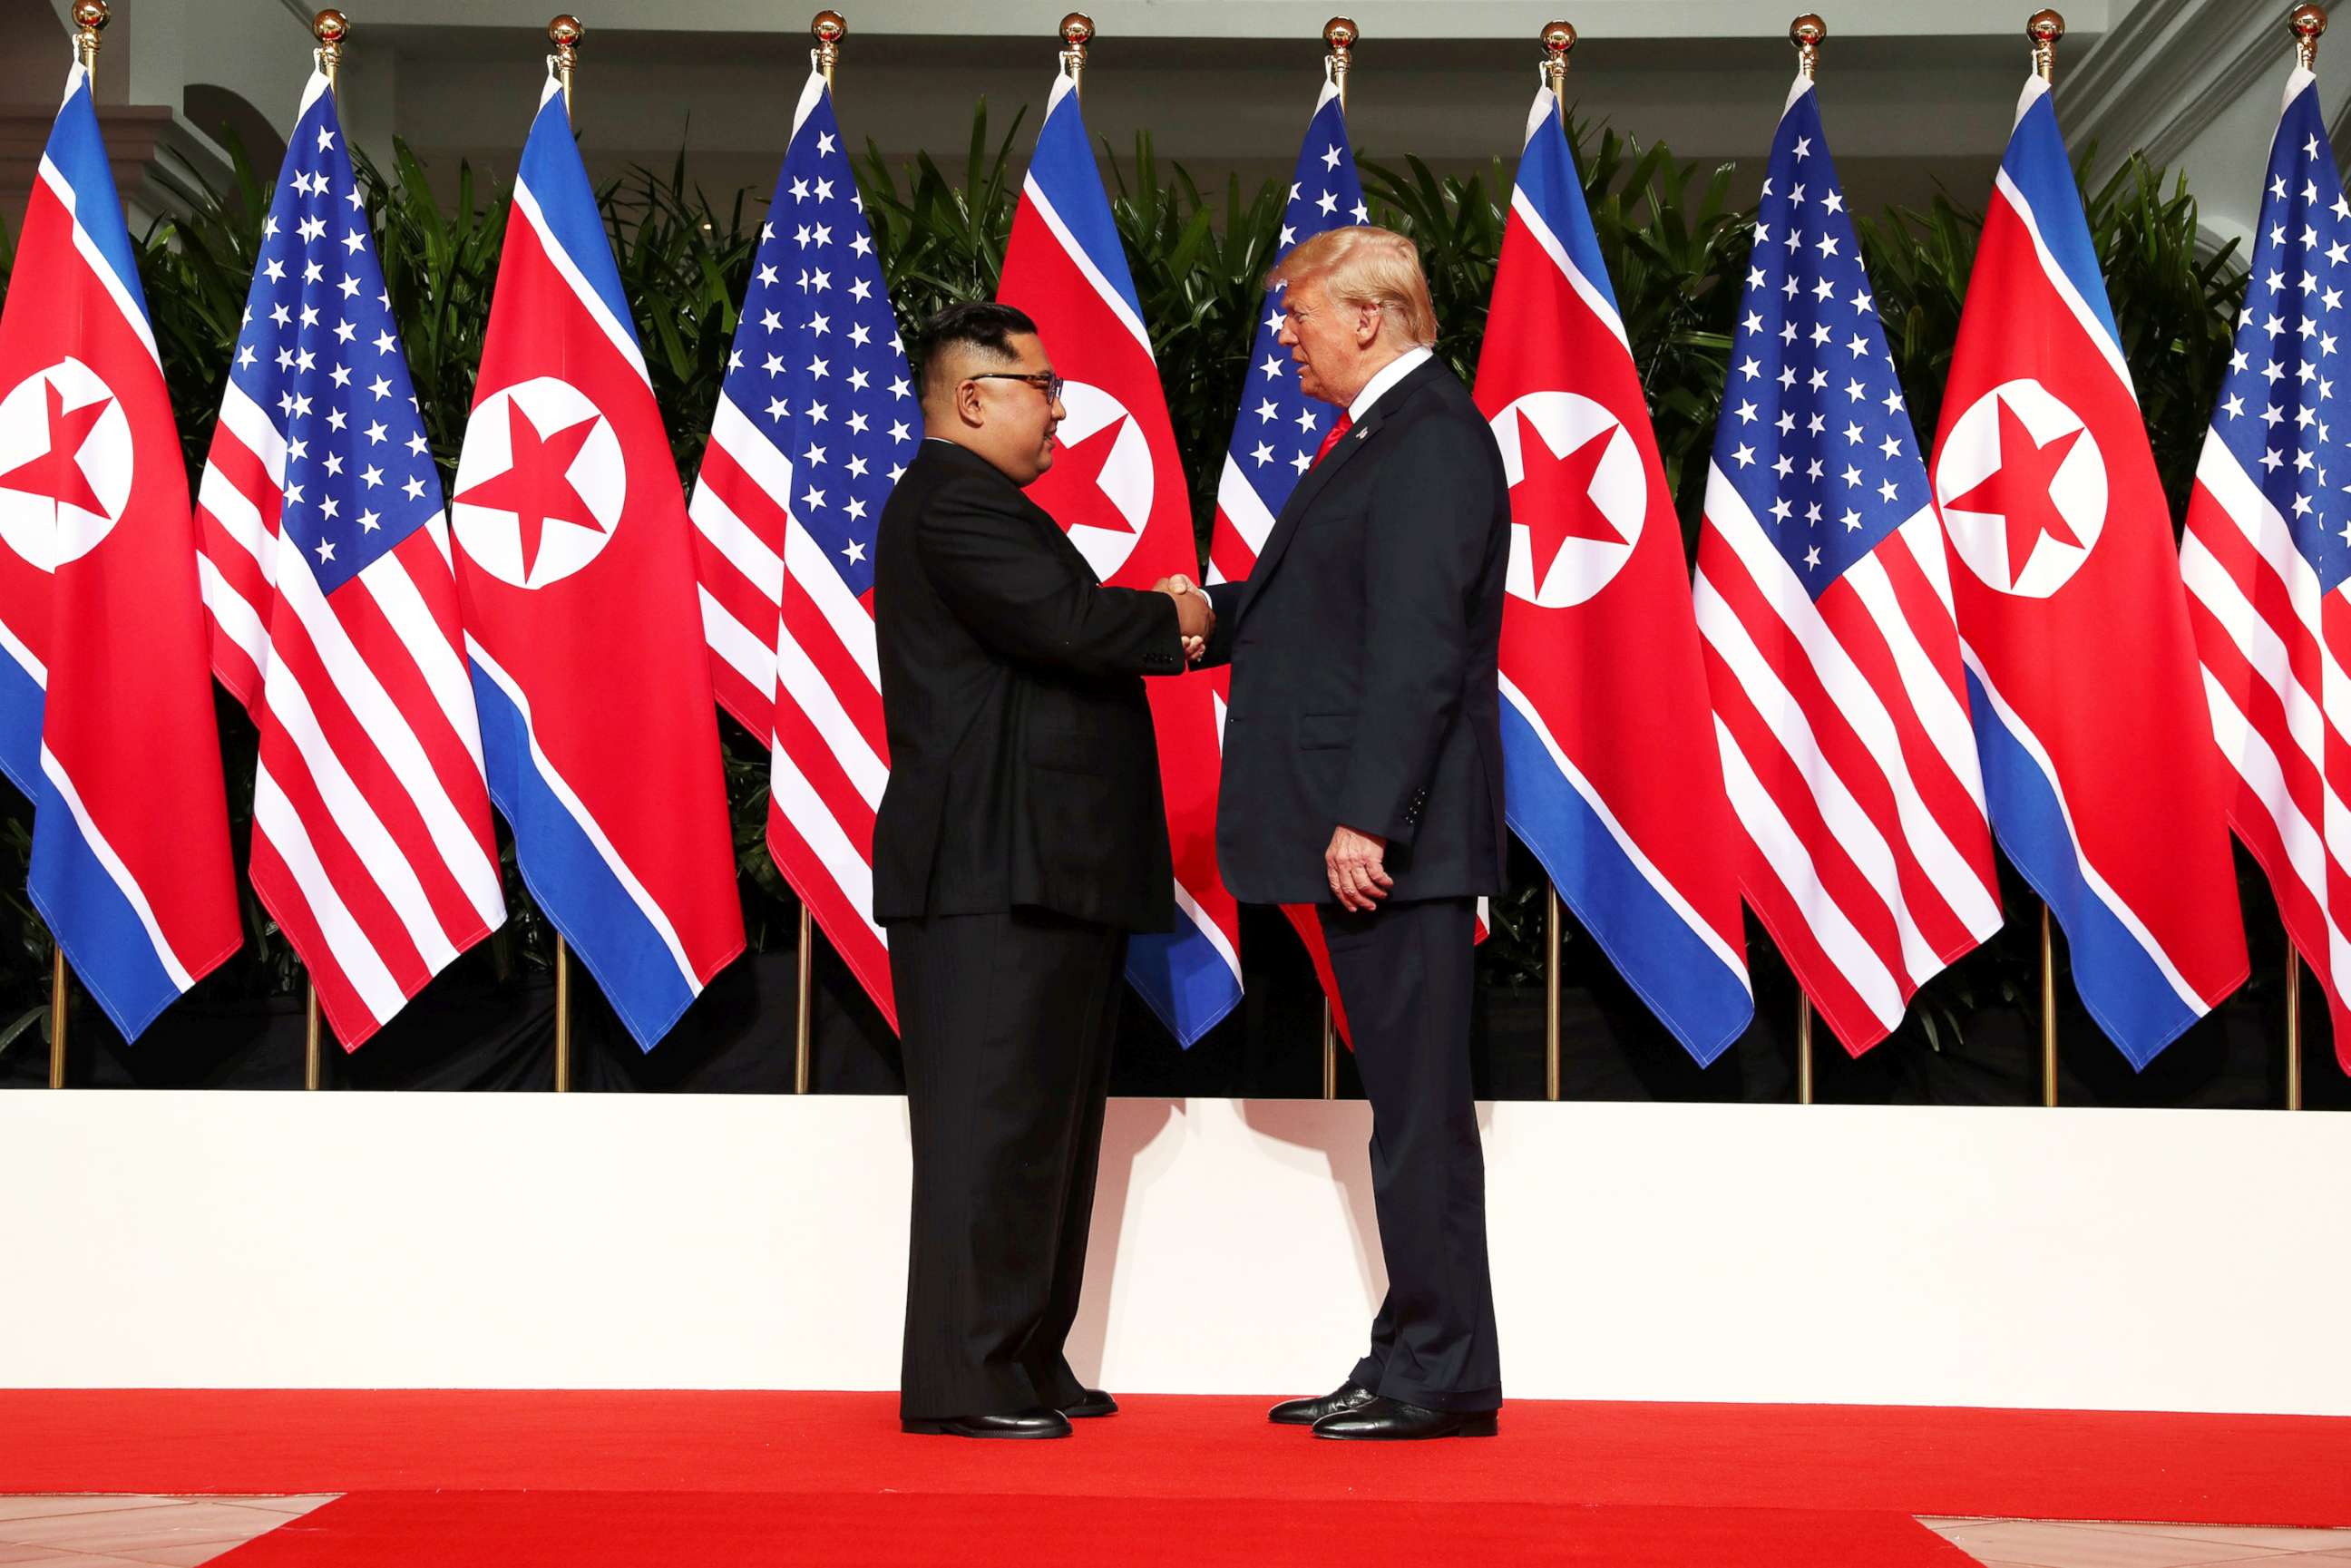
[[1208, 360, 1509, 902]]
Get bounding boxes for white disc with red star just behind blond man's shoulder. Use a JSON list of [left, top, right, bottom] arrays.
[[1490, 393, 1648, 609]]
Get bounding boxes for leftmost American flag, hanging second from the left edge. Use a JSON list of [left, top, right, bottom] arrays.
[[198, 73, 505, 1048]]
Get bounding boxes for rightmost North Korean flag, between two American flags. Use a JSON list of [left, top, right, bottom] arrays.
[[1933, 67, 2248, 1067]]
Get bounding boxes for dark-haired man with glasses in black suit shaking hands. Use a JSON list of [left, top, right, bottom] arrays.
[[874, 303, 1213, 1437]]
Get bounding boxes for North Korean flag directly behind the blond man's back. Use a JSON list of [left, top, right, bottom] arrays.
[[1477, 87, 1754, 1063]]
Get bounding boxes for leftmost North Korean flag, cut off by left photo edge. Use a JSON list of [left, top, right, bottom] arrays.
[[0, 66, 242, 1039]]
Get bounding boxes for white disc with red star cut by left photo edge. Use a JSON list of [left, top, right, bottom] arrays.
[[0, 360, 139, 571]]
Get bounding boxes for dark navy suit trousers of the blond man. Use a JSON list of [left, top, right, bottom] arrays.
[[1317, 898, 1502, 1410]]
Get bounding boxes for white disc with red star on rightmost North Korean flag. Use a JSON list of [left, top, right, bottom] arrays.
[[1935, 378, 2106, 599]]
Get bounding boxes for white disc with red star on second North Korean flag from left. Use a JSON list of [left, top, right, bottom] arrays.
[[449, 376, 628, 588]]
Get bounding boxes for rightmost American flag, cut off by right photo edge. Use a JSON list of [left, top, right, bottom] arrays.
[[2180, 68, 2351, 1067]]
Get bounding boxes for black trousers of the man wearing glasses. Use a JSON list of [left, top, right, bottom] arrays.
[[889, 893, 1127, 1420]]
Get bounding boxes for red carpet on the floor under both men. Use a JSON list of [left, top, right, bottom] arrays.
[[0, 1392, 2351, 1568]]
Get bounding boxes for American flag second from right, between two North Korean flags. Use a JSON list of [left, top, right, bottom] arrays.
[[1695, 78, 2001, 1053]]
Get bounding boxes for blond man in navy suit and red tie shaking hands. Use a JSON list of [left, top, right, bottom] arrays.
[[1206, 228, 1509, 1438]]
